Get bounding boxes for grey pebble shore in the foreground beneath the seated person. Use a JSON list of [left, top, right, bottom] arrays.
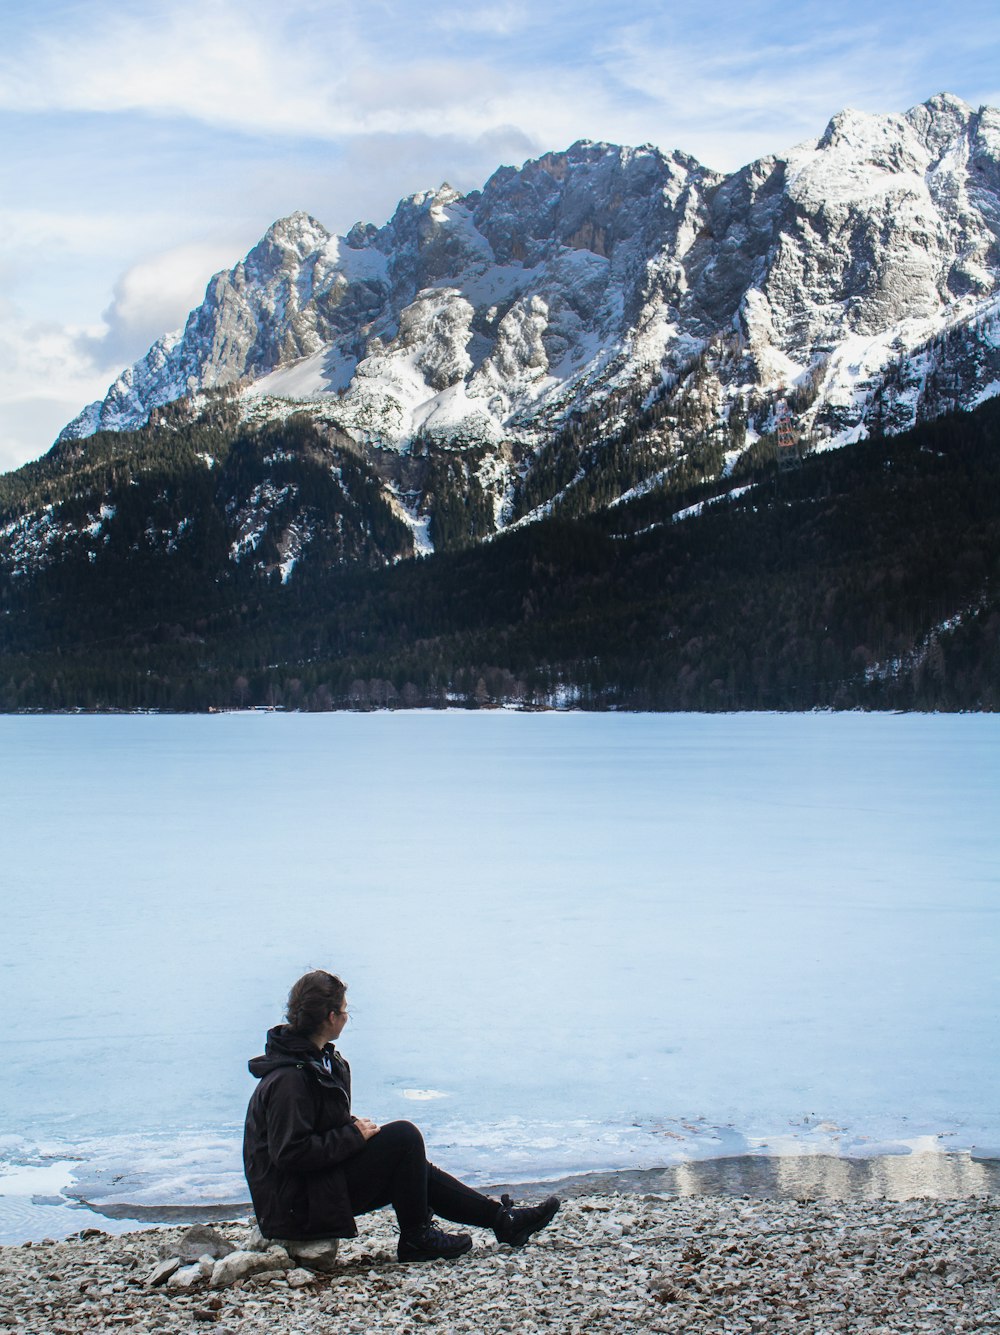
[[0, 1195, 1000, 1335]]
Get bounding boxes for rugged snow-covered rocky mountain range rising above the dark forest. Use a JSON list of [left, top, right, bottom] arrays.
[[44, 95, 1000, 552]]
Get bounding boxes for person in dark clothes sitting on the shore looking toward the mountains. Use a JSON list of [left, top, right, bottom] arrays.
[[243, 969, 559, 1262]]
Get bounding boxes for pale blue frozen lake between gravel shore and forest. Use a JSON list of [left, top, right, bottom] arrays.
[[0, 713, 1000, 1240]]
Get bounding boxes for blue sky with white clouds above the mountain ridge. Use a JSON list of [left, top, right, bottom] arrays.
[[0, 0, 1000, 469]]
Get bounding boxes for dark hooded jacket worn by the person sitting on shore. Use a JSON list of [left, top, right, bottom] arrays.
[[243, 1024, 364, 1238]]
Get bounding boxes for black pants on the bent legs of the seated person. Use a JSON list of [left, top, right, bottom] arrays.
[[340, 1121, 499, 1234]]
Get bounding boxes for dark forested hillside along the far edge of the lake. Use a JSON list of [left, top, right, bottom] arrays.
[[0, 401, 1000, 710]]
